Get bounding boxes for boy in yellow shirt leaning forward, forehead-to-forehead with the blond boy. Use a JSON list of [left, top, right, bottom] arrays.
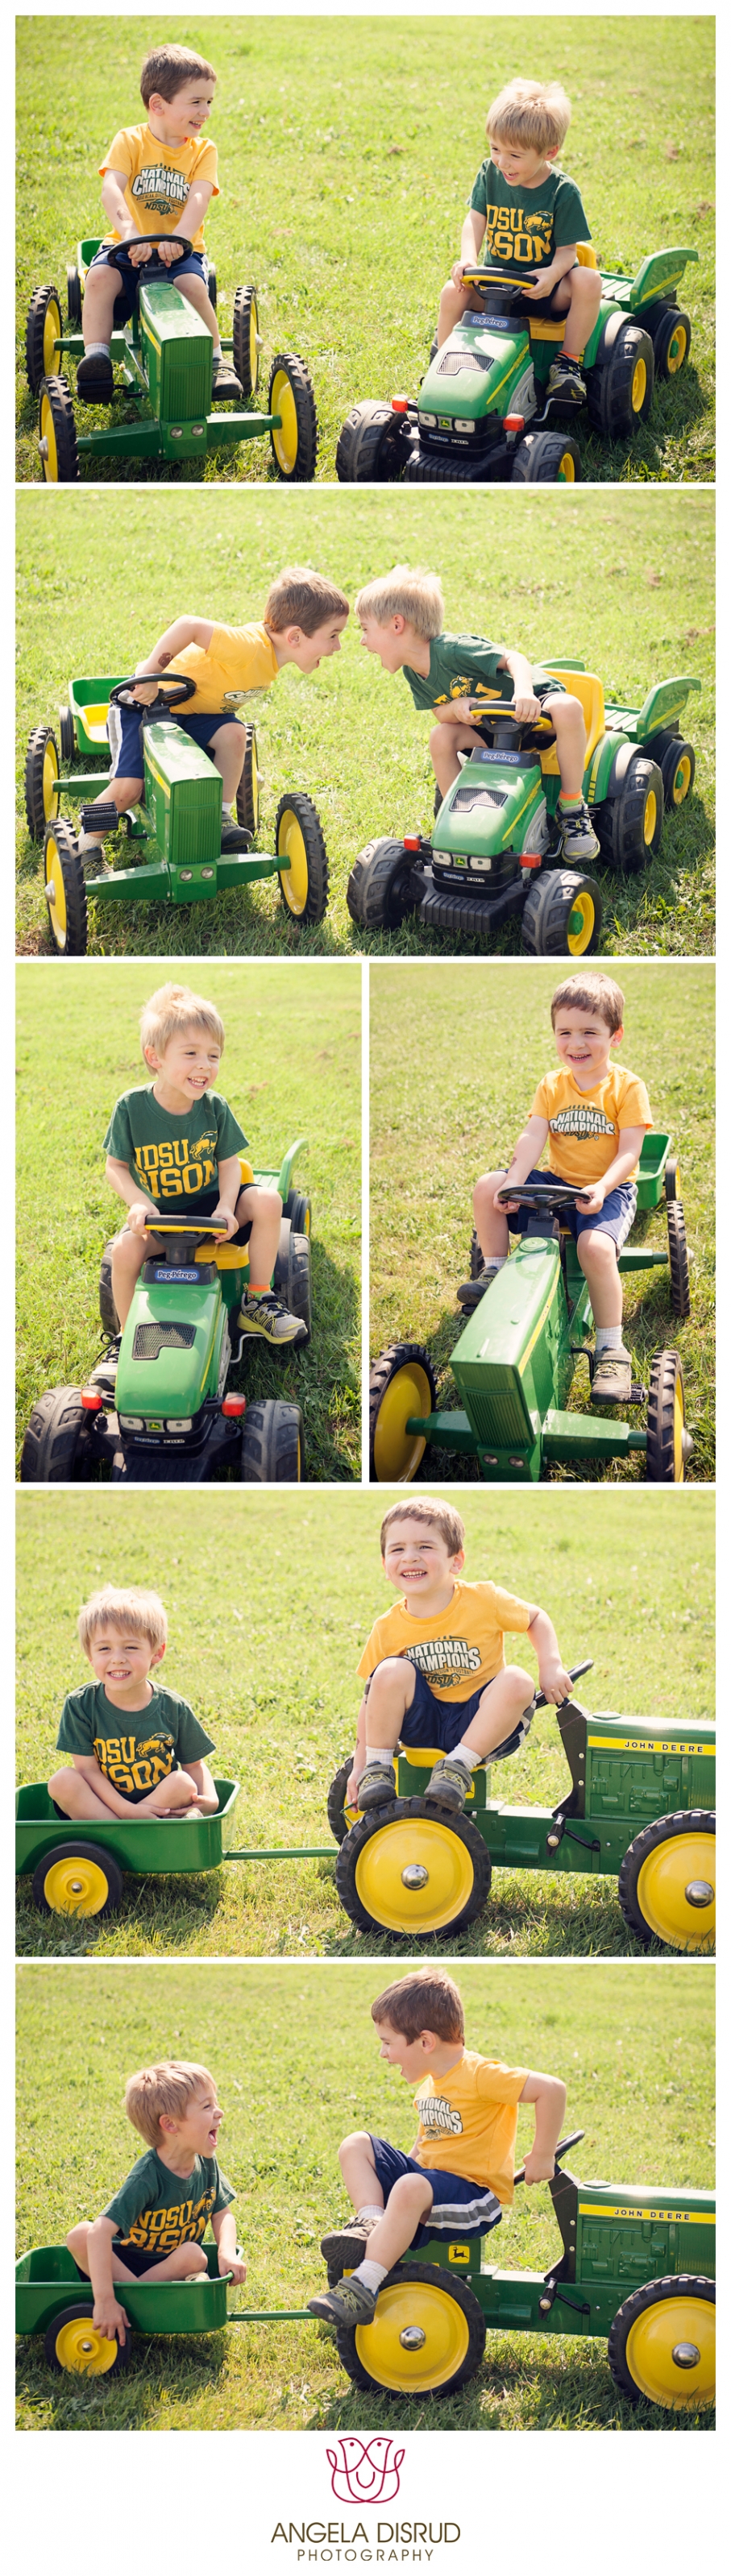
[[77, 564, 347, 858]]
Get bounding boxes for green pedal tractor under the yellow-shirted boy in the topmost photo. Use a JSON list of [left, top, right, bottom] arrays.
[[26, 232, 317, 482]]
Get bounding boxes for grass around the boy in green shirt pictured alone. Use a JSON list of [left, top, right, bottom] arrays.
[[18, 958, 360, 1481]]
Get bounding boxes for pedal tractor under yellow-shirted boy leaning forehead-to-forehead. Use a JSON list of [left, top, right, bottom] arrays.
[[26, 670, 327, 958]]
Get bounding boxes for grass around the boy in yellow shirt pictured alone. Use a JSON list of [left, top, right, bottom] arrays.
[[371, 960, 716, 1483]]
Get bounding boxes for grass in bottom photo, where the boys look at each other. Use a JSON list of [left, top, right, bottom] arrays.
[[18, 1960, 713, 2434]]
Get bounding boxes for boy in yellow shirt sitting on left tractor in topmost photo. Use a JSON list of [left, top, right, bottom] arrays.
[[77, 44, 242, 402]]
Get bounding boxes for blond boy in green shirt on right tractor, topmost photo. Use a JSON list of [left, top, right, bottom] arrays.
[[438, 80, 602, 404]]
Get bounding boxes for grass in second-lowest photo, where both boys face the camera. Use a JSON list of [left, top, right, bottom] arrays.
[[15, 1489, 713, 1960]]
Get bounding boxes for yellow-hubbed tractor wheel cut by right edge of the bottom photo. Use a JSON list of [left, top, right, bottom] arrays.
[[608, 2272, 716, 2414]]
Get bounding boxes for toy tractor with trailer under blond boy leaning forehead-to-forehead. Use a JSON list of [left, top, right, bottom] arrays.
[[347, 657, 700, 958]]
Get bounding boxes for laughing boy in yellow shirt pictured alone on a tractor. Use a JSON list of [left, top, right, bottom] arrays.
[[474, 973, 651, 1404]]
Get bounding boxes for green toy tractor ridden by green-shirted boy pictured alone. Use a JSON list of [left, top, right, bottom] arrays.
[[21, 1139, 311, 1483]]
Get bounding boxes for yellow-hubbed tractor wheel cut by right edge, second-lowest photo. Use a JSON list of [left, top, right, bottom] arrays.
[[617, 1806, 716, 1950]]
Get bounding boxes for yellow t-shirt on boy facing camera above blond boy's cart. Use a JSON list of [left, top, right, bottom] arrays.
[[358, 1577, 530, 1708]]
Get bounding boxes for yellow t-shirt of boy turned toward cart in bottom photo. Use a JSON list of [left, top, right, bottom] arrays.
[[414, 2048, 528, 2202]]
